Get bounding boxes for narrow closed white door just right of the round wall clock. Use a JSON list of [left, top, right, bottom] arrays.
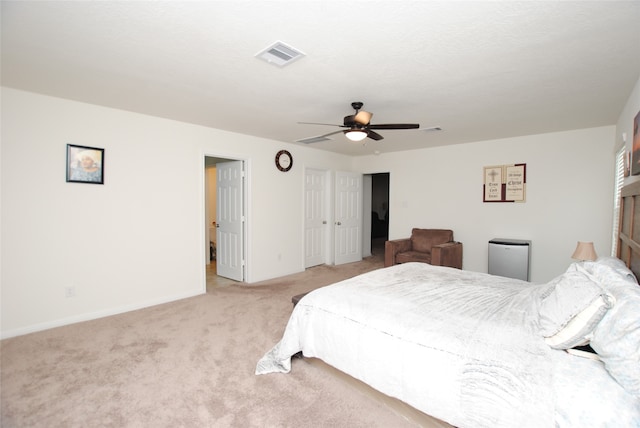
[[304, 168, 328, 268]]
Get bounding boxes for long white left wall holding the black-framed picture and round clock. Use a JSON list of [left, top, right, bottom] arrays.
[[0, 88, 352, 337]]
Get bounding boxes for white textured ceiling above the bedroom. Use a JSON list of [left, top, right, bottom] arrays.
[[1, 0, 640, 155]]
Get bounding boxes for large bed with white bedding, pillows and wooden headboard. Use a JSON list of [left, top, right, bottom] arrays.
[[256, 185, 640, 427]]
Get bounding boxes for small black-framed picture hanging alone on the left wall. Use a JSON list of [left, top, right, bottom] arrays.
[[67, 144, 104, 184]]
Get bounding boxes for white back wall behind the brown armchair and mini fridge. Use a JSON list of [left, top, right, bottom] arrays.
[[356, 126, 615, 282]]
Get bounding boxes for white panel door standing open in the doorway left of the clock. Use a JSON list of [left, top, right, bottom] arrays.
[[216, 161, 244, 281]]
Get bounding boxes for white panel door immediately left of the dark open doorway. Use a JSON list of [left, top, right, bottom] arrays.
[[334, 171, 362, 265]]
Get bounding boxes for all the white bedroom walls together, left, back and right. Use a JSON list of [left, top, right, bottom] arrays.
[[0, 77, 640, 337]]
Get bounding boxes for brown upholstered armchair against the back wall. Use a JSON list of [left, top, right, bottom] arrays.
[[384, 228, 462, 269]]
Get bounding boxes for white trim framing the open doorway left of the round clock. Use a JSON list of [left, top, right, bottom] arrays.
[[198, 150, 252, 293]]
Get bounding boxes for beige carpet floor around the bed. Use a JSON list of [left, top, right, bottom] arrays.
[[0, 249, 444, 428]]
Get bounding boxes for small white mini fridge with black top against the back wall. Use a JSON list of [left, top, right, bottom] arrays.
[[489, 238, 531, 281]]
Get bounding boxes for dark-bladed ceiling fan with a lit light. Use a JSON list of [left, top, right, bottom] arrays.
[[298, 101, 420, 142]]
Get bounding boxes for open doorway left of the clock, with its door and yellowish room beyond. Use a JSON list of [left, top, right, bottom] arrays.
[[204, 156, 246, 291]]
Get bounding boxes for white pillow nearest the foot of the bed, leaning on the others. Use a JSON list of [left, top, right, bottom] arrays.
[[538, 271, 614, 349]]
